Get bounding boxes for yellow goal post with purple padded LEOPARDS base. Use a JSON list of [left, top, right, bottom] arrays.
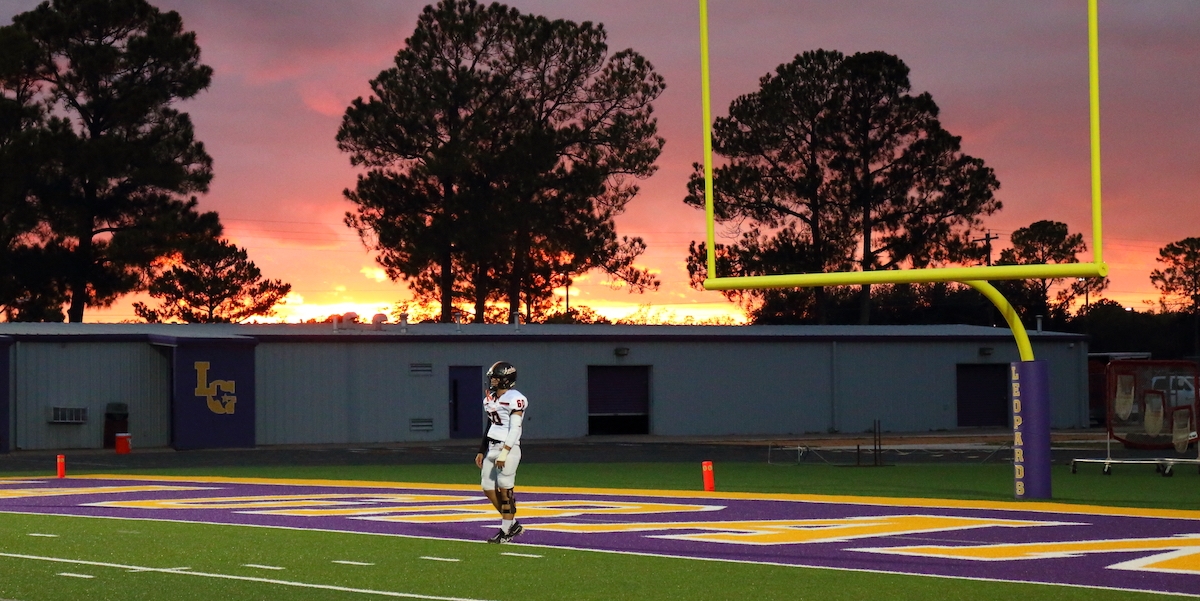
[[700, 0, 1109, 498]]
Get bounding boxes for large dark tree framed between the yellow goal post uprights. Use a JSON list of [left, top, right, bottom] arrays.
[[685, 50, 1001, 324]]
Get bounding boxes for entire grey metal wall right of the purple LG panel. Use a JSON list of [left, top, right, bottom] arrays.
[[250, 337, 1086, 444]]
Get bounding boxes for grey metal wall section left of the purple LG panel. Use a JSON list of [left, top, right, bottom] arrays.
[[12, 342, 170, 449]]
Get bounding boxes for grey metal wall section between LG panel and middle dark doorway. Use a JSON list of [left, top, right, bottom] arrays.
[[254, 337, 604, 445]]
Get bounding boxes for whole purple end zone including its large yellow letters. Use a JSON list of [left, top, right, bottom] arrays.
[[0, 477, 1200, 595]]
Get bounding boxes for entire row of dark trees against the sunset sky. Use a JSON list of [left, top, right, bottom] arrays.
[[0, 0, 1200, 343]]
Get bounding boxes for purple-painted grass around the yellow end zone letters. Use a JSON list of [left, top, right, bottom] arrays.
[[0, 479, 1200, 594]]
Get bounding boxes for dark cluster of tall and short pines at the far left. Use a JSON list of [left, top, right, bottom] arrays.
[[0, 0, 290, 321]]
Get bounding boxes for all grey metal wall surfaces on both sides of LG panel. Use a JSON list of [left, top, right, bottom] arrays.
[[2, 335, 1087, 449]]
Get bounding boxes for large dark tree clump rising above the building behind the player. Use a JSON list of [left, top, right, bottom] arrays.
[[337, 0, 662, 321]]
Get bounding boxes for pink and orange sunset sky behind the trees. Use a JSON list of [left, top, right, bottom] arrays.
[[0, 0, 1200, 321]]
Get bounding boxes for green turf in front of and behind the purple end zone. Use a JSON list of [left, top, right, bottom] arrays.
[[0, 463, 1200, 601]]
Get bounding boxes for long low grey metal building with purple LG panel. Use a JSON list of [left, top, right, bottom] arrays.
[[0, 324, 1088, 452]]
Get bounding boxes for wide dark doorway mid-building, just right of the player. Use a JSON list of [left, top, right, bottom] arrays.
[[588, 365, 650, 434]]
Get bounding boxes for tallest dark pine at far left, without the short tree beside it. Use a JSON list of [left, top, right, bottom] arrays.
[[0, 0, 220, 321]]
